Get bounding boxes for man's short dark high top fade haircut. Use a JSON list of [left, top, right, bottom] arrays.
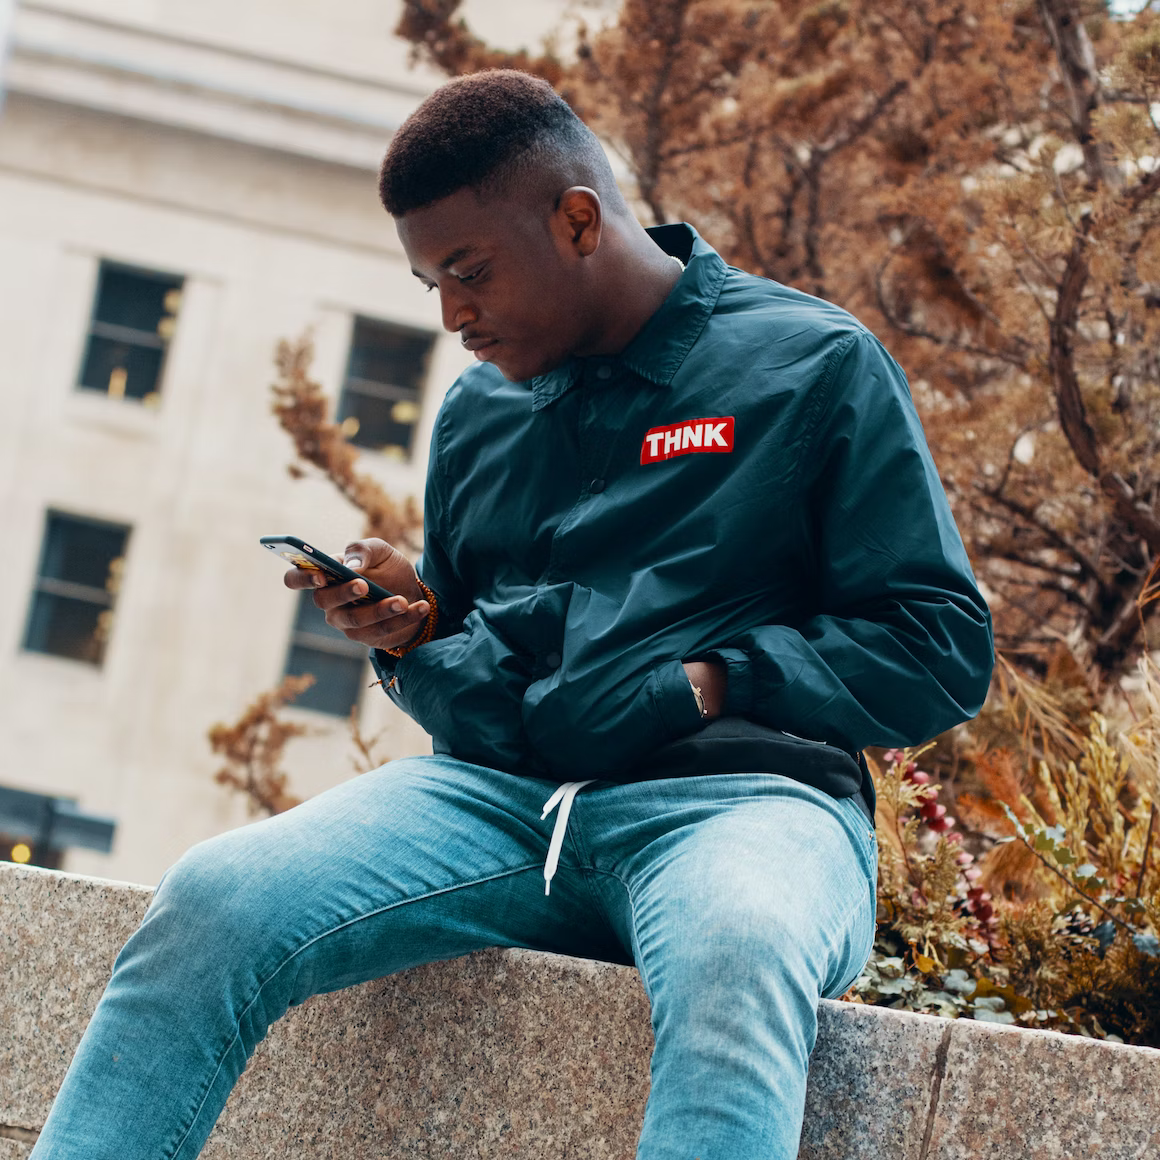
[[378, 68, 628, 217]]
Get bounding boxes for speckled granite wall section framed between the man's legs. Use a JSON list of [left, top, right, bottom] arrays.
[[203, 951, 652, 1160]]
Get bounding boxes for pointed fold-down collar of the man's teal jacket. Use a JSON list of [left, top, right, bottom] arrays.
[[528, 223, 728, 411]]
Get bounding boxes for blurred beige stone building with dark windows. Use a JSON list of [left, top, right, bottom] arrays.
[[0, 0, 561, 883]]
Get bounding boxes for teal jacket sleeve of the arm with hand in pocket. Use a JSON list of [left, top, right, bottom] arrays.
[[704, 331, 994, 751]]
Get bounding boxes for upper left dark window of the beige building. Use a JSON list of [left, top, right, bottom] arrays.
[[80, 262, 182, 406]]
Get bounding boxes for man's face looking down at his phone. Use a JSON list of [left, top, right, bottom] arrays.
[[396, 189, 585, 382]]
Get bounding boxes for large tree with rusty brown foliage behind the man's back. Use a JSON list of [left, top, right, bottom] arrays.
[[400, 0, 1160, 673]]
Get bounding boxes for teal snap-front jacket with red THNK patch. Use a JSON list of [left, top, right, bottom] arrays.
[[372, 225, 993, 780]]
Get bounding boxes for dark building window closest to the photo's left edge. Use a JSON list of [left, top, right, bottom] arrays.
[[24, 512, 129, 665]]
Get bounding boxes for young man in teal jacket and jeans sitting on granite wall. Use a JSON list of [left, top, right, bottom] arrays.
[[32, 72, 992, 1160]]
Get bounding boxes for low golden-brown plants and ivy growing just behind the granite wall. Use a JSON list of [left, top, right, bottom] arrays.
[[856, 658, 1160, 1046]]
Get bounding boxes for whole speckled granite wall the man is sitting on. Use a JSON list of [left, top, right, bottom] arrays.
[[0, 865, 1160, 1160]]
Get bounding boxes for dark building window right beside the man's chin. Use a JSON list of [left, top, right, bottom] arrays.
[[339, 318, 435, 459]]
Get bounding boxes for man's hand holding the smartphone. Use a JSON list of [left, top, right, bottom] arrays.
[[283, 539, 432, 648]]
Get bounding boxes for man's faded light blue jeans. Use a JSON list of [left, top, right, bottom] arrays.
[[32, 756, 877, 1160]]
